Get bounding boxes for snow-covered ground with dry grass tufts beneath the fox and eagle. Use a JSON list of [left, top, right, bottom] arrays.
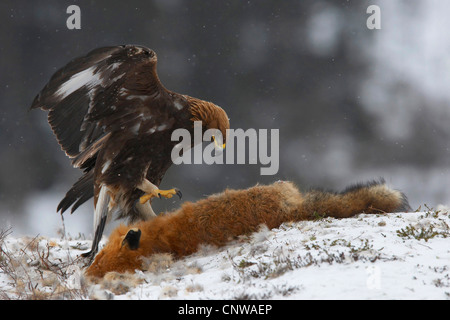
[[0, 207, 450, 300]]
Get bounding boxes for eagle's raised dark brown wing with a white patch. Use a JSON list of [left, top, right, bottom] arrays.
[[31, 45, 184, 170]]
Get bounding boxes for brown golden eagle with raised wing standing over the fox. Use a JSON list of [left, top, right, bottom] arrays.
[[31, 45, 229, 256]]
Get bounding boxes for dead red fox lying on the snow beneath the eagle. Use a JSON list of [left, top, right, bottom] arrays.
[[86, 180, 410, 277]]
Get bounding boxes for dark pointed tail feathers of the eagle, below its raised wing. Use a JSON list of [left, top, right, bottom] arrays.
[[57, 170, 94, 213]]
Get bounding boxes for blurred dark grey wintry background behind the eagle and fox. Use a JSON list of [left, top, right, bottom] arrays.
[[0, 0, 450, 237]]
